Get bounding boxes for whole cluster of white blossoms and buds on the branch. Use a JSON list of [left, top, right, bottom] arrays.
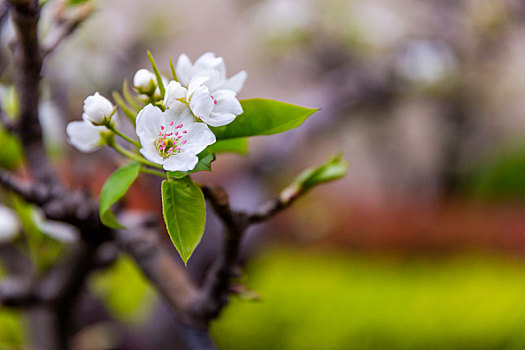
[[67, 52, 246, 171]]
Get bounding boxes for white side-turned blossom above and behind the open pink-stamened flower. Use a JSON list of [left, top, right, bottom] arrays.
[[171, 52, 246, 126]]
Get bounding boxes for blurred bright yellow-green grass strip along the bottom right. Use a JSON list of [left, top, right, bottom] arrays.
[[212, 249, 525, 350]]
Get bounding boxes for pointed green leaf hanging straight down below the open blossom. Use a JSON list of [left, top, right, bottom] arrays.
[[162, 177, 206, 264]]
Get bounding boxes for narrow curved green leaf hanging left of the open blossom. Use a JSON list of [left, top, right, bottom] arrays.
[[99, 162, 140, 228]]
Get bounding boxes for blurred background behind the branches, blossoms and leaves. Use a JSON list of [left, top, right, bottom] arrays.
[[0, 0, 525, 350]]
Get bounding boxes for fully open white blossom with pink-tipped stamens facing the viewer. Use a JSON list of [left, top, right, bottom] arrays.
[[137, 104, 215, 171]]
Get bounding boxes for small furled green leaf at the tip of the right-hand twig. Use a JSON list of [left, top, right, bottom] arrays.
[[295, 154, 348, 191]]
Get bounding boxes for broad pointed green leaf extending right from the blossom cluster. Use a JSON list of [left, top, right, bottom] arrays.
[[211, 98, 317, 140]]
